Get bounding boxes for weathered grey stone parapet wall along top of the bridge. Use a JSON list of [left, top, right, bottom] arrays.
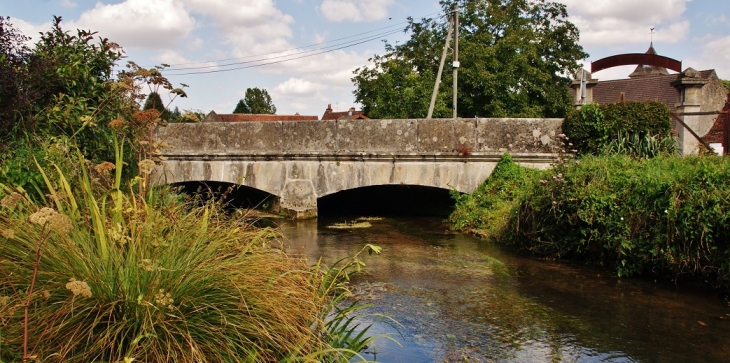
[[158, 118, 563, 155]]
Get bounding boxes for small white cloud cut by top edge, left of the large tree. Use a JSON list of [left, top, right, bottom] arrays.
[[320, 0, 395, 22]]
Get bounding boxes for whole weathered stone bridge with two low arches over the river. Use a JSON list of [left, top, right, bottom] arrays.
[[153, 118, 563, 218]]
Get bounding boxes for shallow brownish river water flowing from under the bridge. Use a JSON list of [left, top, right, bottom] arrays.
[[278, 217, 730, 363]]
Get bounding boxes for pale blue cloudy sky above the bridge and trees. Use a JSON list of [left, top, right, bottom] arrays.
[[0, 0, 730, 117]]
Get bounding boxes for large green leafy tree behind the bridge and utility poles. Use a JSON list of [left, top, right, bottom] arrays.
[[352, 0, 588, 118]]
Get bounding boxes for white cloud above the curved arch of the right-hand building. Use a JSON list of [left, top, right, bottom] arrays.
[[558, 0, 690, 46]]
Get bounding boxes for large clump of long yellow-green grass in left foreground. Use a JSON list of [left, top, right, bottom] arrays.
[[0, 150, 367, 362]]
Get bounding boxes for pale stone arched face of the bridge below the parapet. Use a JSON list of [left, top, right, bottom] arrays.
[[154, 157, 498, 218]]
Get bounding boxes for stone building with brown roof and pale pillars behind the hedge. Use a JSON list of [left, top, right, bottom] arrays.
[[571, 44, 730, 154]]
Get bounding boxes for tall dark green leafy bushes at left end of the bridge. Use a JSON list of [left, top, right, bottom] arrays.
[[0, 17, 185, 198]]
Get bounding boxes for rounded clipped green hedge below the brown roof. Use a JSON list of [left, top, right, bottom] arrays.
[[563, 101, 676, 155]]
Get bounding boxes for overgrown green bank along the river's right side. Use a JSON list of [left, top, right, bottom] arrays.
[[451, 155, 730, 291]]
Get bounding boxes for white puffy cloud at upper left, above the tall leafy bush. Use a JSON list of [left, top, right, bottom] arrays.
[[71, 0, 195, 48]]
